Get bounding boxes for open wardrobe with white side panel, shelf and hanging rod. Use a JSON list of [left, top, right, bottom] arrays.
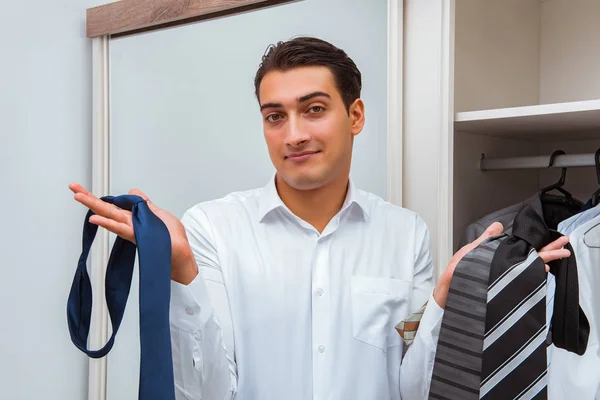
[[402, 0, 600, 273]]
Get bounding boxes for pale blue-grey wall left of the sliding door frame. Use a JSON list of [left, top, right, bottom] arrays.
[[0, 0, 101, 400]]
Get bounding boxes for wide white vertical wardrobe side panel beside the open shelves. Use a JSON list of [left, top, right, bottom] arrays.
[[402, 0, 455, 276]]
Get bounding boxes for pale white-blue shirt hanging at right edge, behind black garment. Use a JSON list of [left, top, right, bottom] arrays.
[[547, 206, 600, 400]]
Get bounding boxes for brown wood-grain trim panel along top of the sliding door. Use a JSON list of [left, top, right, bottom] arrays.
[[86, 0, 299, 38]]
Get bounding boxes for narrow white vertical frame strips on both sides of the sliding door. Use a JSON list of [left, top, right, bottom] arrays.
[[88, 0, 404, 400]]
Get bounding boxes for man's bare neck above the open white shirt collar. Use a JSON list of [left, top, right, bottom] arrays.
[[275, 174, 348, 233]]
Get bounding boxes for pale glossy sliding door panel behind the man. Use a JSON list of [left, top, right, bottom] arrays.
[[107, 0, 388, 400]]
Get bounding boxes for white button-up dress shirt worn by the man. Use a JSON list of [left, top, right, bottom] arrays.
[[171, 179, 443, 400]]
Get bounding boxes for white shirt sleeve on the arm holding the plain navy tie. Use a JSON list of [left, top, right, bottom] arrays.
[[170, 206, 237, 400]]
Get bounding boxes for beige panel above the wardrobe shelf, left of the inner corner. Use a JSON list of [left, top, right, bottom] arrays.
[[455, 0, 541, 112]]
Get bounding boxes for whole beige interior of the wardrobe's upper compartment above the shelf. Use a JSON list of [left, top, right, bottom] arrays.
[[455, 0, 600, 112]]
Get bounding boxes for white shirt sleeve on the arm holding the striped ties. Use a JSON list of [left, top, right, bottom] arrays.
[[400, 219, 444, 400]]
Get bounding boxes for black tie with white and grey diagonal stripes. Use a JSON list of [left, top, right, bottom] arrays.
[[480, 245, 547, 399]]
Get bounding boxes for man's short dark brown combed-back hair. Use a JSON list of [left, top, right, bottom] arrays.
[[254, 37, 362, 110]]
